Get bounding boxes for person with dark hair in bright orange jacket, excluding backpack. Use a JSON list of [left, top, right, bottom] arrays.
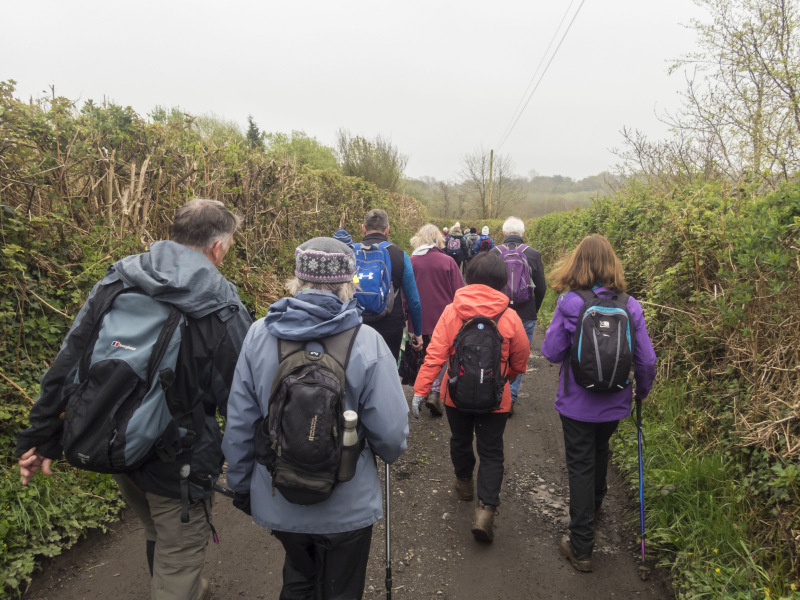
[[411, 252, 530, 542]]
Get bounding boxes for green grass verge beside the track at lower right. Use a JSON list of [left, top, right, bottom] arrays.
[[613, 381, 800, 600]]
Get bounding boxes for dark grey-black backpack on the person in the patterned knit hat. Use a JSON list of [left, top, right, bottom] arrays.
[[255, 326, 364, 505]]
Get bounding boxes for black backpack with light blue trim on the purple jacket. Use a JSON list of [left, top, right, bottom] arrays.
[[564, 290, 635, 393]]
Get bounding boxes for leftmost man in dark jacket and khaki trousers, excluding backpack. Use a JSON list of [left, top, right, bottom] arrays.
[[17, 199, 252, 600]]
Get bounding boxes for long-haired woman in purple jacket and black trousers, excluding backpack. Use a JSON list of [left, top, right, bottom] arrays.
[[542, 235, 656, 571]]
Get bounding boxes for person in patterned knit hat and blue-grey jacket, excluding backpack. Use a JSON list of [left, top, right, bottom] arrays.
[[222, 238, 408, 600]]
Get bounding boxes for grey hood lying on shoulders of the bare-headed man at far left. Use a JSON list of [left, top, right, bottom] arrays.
[[111, 240, 239, 318]]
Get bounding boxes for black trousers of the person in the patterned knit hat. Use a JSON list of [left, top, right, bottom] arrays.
[[272, 525, 372, 600]]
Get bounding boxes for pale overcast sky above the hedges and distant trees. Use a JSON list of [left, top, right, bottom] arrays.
[[0, 0, 705, 180]]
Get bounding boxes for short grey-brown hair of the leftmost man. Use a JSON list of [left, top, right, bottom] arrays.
[[171, 198, 242, 252]]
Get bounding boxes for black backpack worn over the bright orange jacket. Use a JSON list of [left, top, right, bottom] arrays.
[[447, 311, 506, 414]]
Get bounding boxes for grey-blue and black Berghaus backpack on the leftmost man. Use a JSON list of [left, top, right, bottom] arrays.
[[61, 282, 204, 473]]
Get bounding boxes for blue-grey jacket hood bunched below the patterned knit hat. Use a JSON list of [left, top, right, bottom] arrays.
[[264, 290, 361, 341]]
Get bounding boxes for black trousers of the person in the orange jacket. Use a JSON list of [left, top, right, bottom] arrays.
[[445, 406, 508, 506]]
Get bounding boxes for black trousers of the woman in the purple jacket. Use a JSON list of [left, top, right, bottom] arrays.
[[561, 415, 619, 555]]
